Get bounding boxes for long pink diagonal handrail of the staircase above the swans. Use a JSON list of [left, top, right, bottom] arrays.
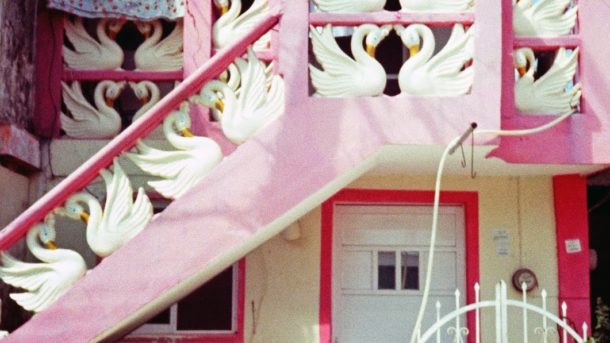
[[0, 9, 281, 250]]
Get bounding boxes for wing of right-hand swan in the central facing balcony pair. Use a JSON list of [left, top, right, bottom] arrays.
[[426, 24, 473, 76]]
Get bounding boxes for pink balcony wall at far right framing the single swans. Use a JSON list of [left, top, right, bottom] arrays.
[[491, 1, 610, 164]]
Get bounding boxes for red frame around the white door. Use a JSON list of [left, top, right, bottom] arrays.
[[319, 189, 479, 343]]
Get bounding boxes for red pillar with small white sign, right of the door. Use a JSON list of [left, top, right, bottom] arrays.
[[553, 175, 591, 328]]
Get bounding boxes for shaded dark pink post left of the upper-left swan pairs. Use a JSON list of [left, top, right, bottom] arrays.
[[32, 6, 63, 138]]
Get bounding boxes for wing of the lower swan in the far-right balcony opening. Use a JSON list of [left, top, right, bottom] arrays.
[[535, 48, 578, 95]]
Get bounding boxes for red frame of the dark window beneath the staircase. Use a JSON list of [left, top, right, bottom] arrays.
[[122, 258, 246, 343]]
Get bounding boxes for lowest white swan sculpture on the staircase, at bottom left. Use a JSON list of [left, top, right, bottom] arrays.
[[0, 215, 87, 312]]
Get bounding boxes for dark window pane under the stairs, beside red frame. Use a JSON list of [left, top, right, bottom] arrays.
[[177, 267, 233, 331]]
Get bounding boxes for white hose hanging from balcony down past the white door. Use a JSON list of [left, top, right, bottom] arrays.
[[410, 113, 572, 343]]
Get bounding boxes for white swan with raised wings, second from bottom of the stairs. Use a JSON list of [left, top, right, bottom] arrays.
[[59, 158, 153, 257]]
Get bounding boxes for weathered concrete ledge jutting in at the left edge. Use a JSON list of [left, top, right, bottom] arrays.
[[0, 124, 40, 169]]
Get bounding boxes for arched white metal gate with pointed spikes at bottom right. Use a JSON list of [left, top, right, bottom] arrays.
[[417, 281, 588, 343]]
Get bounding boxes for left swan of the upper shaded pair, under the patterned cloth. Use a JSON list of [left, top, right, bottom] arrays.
[[63, 17, 125, 70]]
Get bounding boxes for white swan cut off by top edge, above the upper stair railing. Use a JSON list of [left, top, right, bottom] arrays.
[[212, 0, 271, 51]]
